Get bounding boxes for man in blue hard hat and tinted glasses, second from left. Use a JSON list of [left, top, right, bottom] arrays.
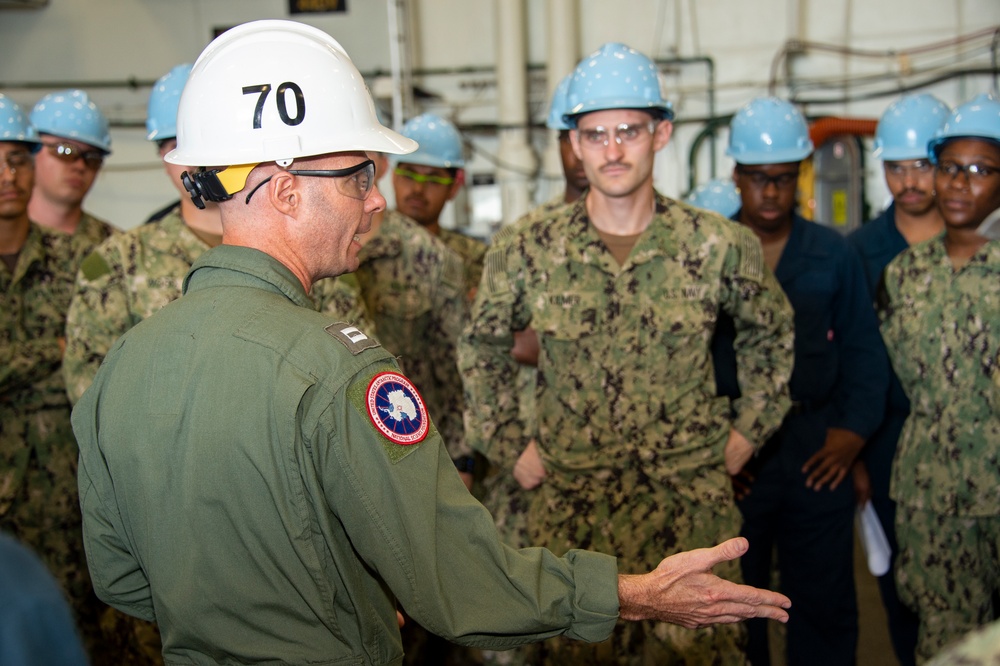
[[28, 89, 117, 259]]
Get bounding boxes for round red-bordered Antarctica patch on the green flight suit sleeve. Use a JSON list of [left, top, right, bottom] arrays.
[[365, 372, 430, 446]]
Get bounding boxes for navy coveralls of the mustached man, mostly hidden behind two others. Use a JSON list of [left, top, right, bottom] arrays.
[[847, 203, 919, 666]]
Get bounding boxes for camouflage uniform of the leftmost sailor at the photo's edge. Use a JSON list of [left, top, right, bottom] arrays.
[[0, 223, 103, 650]]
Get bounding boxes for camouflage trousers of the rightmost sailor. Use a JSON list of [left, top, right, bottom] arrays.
[[896, 504, 1000, 663]]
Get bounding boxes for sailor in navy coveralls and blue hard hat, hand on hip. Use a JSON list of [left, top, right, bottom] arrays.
[[714, 97, 889, 666]]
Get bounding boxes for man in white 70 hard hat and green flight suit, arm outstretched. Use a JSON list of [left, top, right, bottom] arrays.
[[73, 21, 787, 664]]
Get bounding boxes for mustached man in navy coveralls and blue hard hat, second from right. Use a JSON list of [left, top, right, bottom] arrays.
[[847, 94, 949, 666]]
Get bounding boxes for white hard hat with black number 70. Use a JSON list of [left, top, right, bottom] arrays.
[[164, 20, 417, 179]]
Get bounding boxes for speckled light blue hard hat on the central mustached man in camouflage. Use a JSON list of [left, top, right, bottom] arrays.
[[563, 42, 674, 128]]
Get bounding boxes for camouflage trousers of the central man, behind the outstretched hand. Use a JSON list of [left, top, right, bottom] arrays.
[[524, 469, 746, 666]]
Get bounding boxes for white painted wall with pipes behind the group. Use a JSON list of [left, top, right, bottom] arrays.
[[0, 0, 1000, 233]]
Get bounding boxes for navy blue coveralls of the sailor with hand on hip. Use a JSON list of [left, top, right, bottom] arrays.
[[713, 212, 889, 666]]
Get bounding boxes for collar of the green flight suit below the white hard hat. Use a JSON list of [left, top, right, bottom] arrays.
[[184, 245, 315, 310]]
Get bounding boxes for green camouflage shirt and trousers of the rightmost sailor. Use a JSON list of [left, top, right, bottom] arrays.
[[879, 234, 1000, 661]]
